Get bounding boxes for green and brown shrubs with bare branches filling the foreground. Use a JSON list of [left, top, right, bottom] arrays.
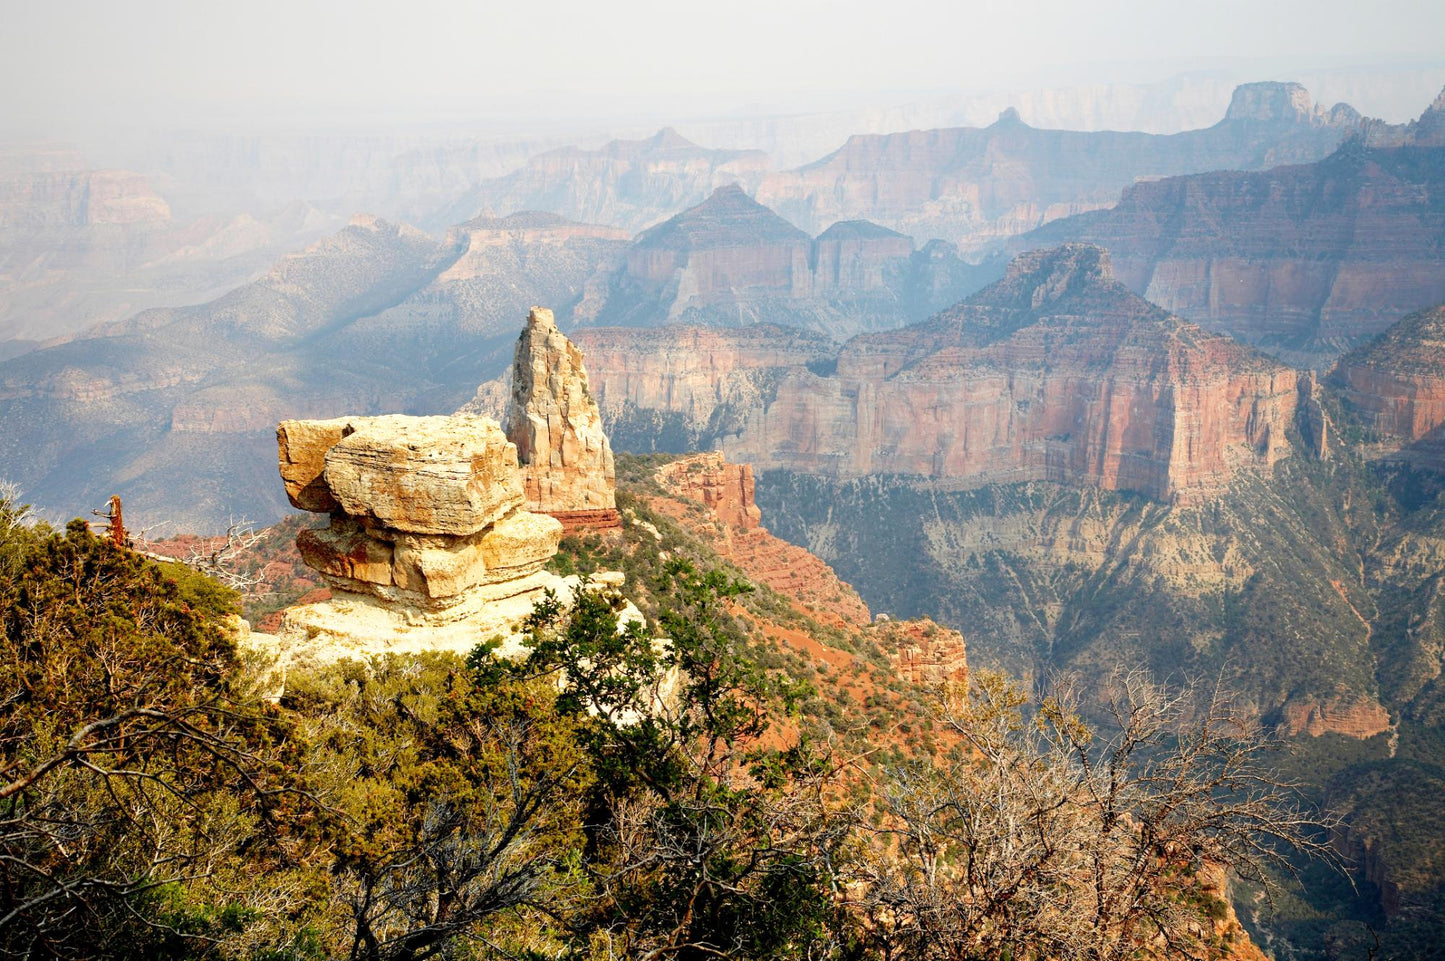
[[0, 500, 1322, 960]]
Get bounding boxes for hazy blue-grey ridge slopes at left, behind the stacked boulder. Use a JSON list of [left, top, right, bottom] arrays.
[[0, 215, 626, 532]]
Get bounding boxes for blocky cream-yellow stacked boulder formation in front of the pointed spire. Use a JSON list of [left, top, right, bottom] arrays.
[[268, 415, 569, 667]]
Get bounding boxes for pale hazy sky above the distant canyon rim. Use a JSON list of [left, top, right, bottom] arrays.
[[0, 0, 1445, 129]]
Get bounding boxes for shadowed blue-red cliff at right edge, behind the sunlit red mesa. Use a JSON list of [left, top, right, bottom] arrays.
[[1016, 143, 1445, 367]]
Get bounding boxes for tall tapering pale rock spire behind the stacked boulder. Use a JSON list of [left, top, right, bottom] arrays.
[[504, 306, 621, 532]]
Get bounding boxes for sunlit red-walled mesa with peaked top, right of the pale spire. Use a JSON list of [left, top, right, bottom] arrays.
[[588, 246, 1298, 499]]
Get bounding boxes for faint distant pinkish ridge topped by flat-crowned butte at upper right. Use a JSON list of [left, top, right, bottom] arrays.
[[757, 84, 1383, 250]]
